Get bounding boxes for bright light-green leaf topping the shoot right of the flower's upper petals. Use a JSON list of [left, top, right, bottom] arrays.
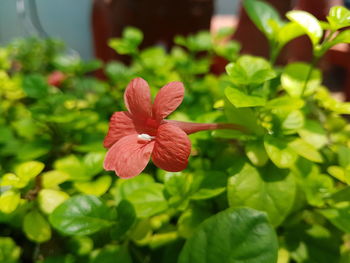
[[226, 55, 276, 85]]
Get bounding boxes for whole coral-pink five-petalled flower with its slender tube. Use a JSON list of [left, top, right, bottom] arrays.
[[103, 78, 242, 178]]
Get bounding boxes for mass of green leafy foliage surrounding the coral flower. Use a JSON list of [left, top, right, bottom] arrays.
[[0, 0, 350, 263]]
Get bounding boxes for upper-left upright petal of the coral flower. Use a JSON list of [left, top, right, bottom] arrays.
[[124, 78, 152, 119]]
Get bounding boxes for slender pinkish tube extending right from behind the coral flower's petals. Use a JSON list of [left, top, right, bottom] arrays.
[[164, 120, 245, 134]]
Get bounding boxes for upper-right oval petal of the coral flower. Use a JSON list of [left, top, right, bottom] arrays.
[[152, 81, 185, 120]]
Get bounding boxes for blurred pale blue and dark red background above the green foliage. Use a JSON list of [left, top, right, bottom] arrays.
[[0, 0, 350, 99]]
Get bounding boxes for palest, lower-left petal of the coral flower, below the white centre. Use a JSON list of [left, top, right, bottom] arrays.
[[103, 135, 154, 178]]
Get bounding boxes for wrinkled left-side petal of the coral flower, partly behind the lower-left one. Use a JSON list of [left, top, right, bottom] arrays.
[[103, 111, 137, 148]]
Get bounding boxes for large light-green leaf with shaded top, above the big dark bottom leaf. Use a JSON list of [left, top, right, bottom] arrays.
[[227, 164, 296, 226]]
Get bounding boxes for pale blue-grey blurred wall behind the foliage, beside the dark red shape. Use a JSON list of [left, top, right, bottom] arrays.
[[0, 0, 238, 59]]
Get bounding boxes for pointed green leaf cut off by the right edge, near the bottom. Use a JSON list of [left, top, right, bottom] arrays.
[[318, 203, 350, 233]]
